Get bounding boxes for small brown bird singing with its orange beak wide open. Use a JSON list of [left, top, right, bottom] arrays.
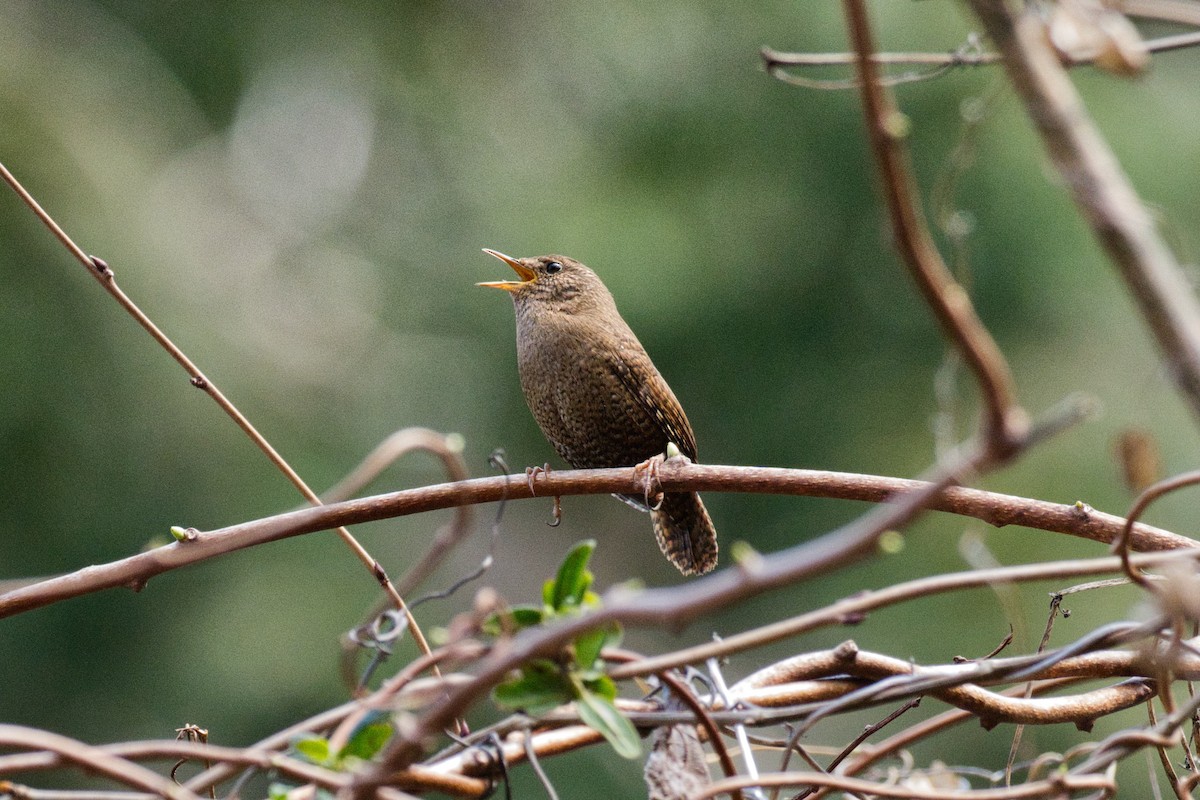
[[479, 248, 716, 575]]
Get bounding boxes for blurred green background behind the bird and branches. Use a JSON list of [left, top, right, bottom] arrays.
[[0, 0, 1200, 798]]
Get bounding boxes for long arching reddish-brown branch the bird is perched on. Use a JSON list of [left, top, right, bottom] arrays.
[[0, 458, 1196, 618]]
